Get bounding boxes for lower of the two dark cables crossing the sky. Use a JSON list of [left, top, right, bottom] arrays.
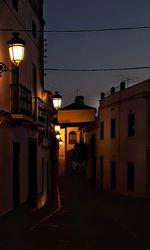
[[44, 66, 150, 72]]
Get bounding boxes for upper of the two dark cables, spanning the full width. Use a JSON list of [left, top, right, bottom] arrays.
[[0, 25, 150, 33]]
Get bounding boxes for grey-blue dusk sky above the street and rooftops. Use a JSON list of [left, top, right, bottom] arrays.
[[44, 0, 150, 107]]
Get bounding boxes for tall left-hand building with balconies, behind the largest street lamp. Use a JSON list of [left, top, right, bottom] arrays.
[[0, 0, 50, 215]]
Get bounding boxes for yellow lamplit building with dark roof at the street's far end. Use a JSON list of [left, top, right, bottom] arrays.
[[58, 96, 96, 175]]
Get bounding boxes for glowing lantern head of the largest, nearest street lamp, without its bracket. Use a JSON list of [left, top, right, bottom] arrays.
[[7, 32, 25, 66]]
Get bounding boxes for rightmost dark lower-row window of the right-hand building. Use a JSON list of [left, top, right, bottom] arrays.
[[127, 162, 135, 192]]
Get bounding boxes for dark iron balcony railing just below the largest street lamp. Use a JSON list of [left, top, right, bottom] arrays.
[[11, 84, 32, 116]]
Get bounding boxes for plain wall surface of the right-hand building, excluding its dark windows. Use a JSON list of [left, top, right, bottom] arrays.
[[99, 82, 149, 196]]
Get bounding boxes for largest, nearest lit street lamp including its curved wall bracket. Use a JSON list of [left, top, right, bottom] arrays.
[[0, 32, 25, 76]]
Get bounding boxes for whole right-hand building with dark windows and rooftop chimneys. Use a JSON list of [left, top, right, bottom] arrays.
[[97, 80, 150, 197]]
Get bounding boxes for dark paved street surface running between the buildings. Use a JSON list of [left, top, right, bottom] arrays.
[[0, 176, 150, 250]]
